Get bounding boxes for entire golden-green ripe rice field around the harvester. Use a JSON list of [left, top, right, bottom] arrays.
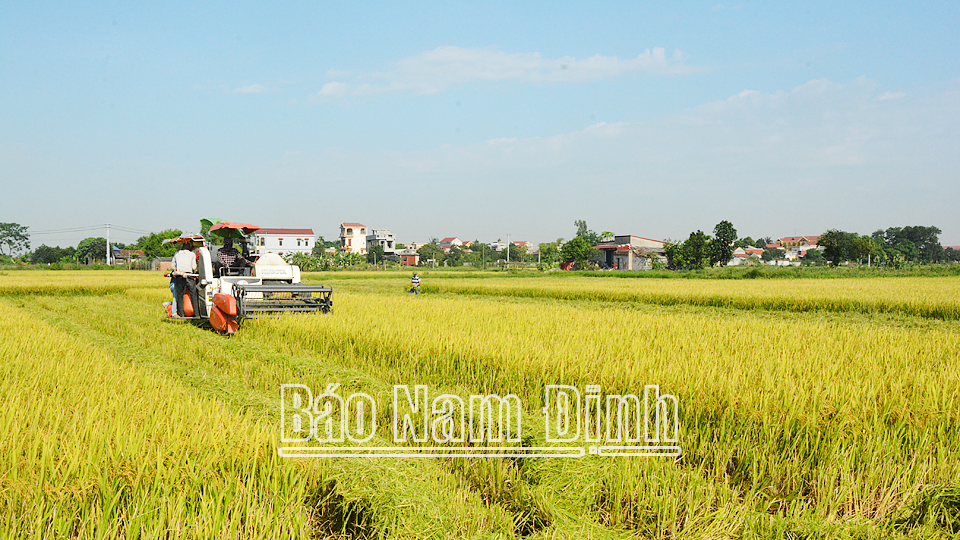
[[0, 272, 960, 538]]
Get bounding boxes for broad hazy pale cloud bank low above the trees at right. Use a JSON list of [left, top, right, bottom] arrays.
[[285, 78, 960, 240]]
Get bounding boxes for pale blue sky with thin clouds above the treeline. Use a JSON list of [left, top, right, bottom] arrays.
[[0, 2, 960, 246]]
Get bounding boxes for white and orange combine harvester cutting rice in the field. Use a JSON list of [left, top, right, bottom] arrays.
[[164, 222, 333, 335]]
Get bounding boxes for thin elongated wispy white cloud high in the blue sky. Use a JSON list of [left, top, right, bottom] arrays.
[[317, 47, 701, 98]]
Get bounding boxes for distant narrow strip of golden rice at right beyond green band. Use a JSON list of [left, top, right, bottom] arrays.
[[422, 277, 960, 320]]
